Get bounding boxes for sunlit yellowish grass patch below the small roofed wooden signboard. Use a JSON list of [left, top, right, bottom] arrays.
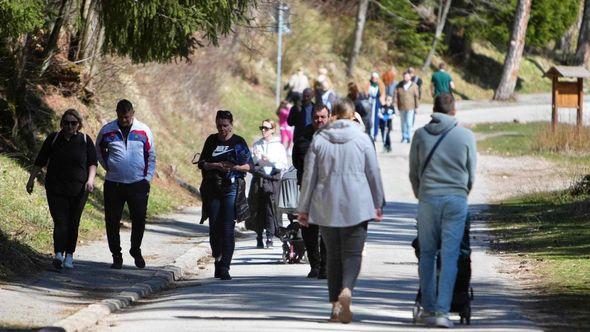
[[472, 122, 590, 166]]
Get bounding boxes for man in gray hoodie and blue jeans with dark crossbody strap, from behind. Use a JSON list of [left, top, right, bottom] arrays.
[[410, 93, 477, 327]]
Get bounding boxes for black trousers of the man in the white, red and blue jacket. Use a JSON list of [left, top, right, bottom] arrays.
[[104, 180, 150, 257]]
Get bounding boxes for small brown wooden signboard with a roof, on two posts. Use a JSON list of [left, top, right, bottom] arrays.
[[545, 66, 590, 131]]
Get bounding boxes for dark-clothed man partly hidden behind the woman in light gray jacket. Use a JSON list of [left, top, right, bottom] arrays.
[[293, 105, 330, 279]]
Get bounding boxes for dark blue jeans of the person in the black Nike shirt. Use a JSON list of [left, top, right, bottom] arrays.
[[207, 183, 238, 270]]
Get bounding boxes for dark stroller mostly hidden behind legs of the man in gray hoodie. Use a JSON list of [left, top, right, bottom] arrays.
[[412, 215, 473, 325]]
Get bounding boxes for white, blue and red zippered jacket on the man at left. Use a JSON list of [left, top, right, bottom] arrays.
[[96, 119, 156, 183]]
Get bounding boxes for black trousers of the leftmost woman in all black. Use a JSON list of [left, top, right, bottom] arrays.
[[47, 189, 88, 254]]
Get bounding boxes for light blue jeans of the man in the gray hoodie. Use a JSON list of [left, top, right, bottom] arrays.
[[416, 195, 467, 314]]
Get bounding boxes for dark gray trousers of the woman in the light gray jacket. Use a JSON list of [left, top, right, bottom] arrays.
[[320, 221, 368, 302]]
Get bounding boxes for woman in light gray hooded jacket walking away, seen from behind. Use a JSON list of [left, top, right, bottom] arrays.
[[297, 99, 384, 323]]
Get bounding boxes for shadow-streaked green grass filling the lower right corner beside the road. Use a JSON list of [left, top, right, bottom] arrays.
[[485, 187, 590, 331]]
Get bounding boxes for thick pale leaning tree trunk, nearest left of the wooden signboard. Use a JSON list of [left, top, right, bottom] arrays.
[[494, 0, 532, 100]]
